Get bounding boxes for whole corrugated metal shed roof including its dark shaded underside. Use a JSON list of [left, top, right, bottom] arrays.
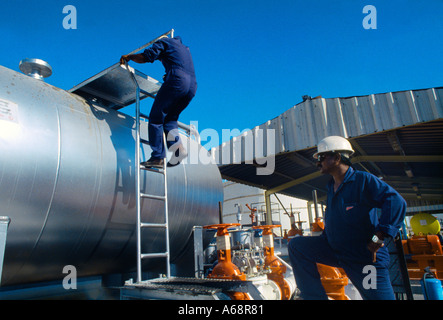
[[213, 87, 443, 211]]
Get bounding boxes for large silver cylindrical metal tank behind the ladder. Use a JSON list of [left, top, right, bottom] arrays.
[[0, 66, 223, 286]]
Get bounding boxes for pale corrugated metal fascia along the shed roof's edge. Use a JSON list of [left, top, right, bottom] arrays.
[[213, 87, 443, 165]]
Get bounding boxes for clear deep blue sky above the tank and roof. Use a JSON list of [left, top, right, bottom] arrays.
[[0, 0, 443, 149]]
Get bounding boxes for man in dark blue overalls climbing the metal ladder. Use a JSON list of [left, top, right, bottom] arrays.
[[120, 36, 197, 167]]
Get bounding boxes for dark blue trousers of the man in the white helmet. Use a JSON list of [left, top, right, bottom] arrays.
[[289, 236, 395, 300]]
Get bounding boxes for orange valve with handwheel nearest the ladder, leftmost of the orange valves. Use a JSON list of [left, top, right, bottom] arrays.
[[203, 223, 246, 280]]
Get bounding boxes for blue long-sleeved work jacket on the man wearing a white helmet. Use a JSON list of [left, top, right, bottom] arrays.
[[323, 167, 406, 264]]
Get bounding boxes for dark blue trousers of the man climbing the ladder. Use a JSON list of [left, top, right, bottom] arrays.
[[148, 69, 197, 159]]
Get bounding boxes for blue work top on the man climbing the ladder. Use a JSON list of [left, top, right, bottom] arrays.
[[143, 36, 195, 80]]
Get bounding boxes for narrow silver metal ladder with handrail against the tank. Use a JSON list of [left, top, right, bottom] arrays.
[[127, 29, 174, 283]]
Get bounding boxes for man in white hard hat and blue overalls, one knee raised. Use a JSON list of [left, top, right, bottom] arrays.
[[289, 136, 406, 300]]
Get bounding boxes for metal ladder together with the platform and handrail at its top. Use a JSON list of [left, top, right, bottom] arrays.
[[69, 29, 200, 282]]
